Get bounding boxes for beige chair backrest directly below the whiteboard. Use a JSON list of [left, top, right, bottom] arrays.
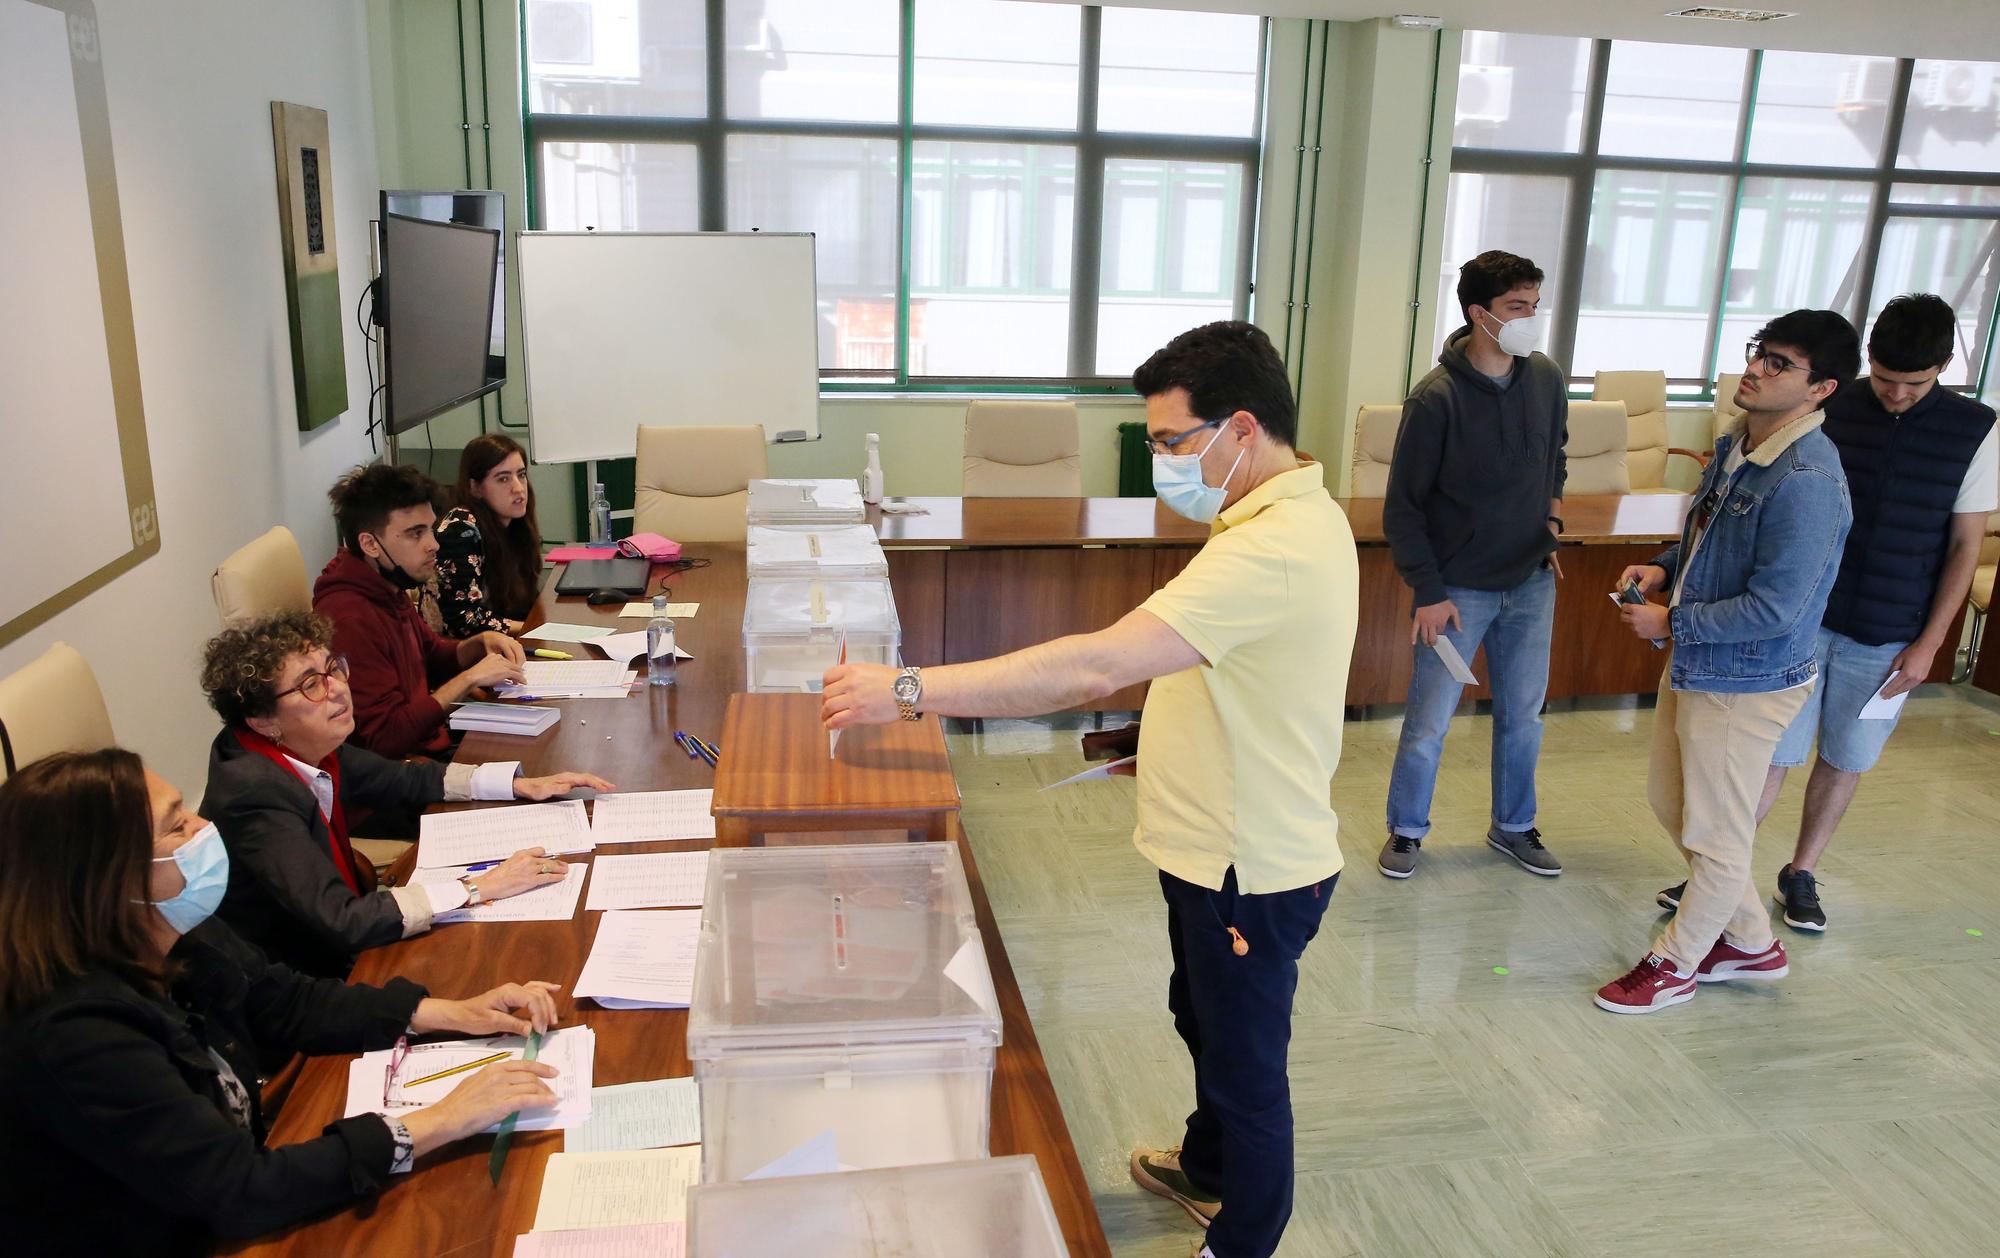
[[632, 424, 770, 542]]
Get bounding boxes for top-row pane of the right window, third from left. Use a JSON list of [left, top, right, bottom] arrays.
[[1750, 52, 1896, 166]]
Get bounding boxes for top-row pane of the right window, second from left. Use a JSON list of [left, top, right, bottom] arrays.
[[1598, 40, 1750, 162]]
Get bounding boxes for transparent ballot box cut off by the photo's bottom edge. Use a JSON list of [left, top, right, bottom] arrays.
[[688, 1154, 1068, 1258]]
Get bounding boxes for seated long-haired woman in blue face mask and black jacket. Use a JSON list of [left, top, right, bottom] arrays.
[[0, 748, 556, 1254]]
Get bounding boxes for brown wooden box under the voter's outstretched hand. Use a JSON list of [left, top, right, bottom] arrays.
[[712, 694, 958, 848]]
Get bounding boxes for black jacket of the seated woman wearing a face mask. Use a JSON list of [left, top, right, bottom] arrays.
[[0, 922, 426, 1254]]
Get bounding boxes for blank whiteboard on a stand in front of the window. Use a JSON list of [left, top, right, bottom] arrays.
[[514, 232, 820, 462]]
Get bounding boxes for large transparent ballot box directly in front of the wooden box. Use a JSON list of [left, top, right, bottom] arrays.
[[688, 842, 1000, 1182]]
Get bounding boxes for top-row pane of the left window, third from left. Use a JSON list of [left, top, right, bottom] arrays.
[[914, 0, 1084, 128]]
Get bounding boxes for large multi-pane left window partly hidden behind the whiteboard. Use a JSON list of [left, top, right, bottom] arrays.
[[524, 0, 1264, 388]]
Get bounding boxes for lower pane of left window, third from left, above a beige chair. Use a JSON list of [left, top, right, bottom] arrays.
[[910, 140, 1076, 376]]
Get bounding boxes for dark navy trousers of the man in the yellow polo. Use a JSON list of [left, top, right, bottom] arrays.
[[1160, 870, 1340, 1258]]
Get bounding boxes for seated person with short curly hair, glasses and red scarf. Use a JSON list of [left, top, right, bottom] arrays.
[[202, 612, 612, 978]]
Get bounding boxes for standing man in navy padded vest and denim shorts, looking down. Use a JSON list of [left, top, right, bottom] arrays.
[[1658, 292, 2000, 934]]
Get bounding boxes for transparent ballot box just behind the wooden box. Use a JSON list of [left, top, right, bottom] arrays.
[[744, 576, 902, 692]]
